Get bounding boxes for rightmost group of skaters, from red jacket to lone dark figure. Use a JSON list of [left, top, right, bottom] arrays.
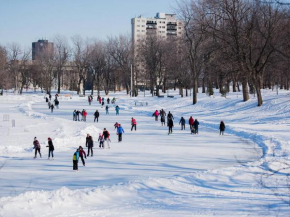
[[152, 109, 226, 135]]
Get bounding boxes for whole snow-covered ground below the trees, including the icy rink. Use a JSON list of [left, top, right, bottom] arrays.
[[0, 90, 290, 217]]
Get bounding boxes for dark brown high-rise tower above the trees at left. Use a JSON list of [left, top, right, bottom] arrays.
[[32, 40, 54, 60]]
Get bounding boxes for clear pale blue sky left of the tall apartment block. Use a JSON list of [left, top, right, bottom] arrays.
[[0, 0, 176, 47]]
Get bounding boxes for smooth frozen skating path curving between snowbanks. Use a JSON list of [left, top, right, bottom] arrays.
[[0, 93, 262, 196]]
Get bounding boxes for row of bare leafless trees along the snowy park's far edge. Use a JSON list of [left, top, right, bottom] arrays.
[[0, 0, 290, 106]]
